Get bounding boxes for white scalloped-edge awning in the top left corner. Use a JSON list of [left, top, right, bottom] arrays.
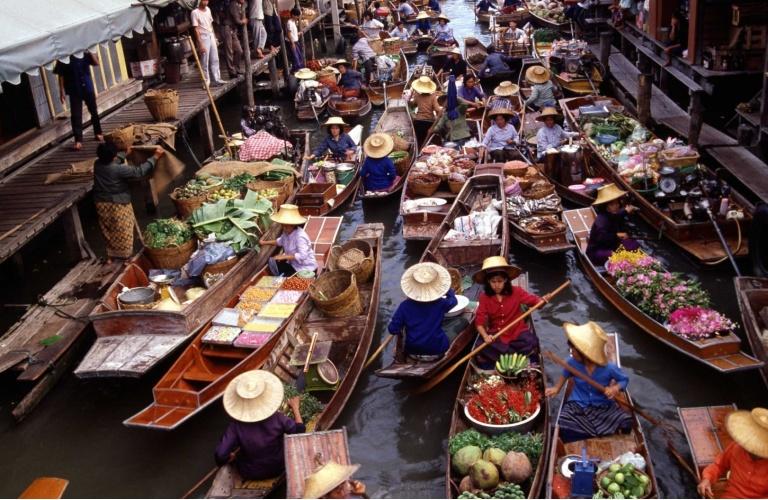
[[0, 0, 170, 84]]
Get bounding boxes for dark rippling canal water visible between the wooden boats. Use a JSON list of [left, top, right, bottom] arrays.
[[0, 0, 765, 498]]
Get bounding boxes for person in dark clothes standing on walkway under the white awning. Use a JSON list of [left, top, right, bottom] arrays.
[[53, 51, 104, 151]]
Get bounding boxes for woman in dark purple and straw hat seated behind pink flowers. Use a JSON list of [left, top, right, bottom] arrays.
[[586, 184, 640, 266]]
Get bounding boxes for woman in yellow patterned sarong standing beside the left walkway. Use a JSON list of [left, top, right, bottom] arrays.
[[93, 142, 165, 263]]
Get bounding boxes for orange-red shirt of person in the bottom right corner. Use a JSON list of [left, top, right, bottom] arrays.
[[702, 443, 768, 498]]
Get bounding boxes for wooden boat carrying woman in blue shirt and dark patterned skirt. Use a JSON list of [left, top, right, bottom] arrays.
[[544, 333, 659, 498]]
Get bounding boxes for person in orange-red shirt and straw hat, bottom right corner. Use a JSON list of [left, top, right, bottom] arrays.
[[697, 408, 768, 498]]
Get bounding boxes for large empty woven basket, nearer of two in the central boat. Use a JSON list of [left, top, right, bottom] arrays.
[[309, 269, 363, 318]]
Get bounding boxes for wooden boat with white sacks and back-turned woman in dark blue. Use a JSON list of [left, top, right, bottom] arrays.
[[376, 170, 509, 379]]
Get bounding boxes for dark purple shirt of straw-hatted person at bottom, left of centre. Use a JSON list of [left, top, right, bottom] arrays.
[[216, 411, 306, 480]]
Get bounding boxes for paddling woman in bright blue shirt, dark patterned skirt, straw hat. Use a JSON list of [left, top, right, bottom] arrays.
[[545, 321, 632, 443]]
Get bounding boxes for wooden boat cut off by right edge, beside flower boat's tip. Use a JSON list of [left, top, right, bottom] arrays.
[[733, 276, 768, 386]]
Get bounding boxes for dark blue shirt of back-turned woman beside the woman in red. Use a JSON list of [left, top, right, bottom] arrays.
[[388, 289, 458, 355]]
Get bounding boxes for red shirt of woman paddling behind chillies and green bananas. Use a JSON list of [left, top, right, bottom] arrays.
[[475, 286, 541, 344]]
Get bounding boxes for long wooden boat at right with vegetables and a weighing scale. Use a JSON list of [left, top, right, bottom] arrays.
[[560, 96, 754, 263]]
